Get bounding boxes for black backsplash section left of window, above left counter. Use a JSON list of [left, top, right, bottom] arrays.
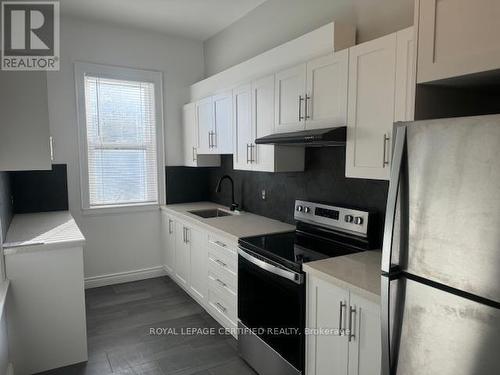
[[9, 164, 68, 214]]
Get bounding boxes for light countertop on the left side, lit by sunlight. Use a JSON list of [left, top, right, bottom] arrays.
[[3, 211, 85, 255]]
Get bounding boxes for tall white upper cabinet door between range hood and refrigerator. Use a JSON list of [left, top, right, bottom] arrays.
[[346, 33, 396, 180]]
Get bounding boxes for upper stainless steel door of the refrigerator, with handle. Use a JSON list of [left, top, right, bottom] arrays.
[[384, 115, 500, 302]]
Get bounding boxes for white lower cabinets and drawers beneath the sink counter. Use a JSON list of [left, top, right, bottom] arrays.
[[162, 211, 238, 337]]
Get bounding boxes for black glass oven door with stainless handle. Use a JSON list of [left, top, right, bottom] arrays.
[[238, 248, 305, 372]]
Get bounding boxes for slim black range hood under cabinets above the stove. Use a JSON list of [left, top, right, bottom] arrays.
[[255, 126, 347, 147]]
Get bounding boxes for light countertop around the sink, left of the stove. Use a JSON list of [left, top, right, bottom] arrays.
[[161, 202, 295, 242]]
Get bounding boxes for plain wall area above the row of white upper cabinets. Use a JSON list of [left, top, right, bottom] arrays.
[[204, 0, 414, 77]]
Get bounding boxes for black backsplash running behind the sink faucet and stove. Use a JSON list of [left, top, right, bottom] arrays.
[[166, 147, 389, 244]]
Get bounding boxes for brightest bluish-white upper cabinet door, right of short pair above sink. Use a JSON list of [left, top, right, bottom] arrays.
[[212, 92, 233, 154]]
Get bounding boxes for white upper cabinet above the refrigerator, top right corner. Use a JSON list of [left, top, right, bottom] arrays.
[[415, 0, 500, 83]]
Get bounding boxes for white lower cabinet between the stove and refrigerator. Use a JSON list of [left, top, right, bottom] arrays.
[[306, 275, 381, 375]]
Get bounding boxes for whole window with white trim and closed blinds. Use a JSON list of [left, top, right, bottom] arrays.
[[75, 63, 164, 213]]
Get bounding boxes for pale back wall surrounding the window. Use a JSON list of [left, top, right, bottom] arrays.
[[48, 18, 203, 277]]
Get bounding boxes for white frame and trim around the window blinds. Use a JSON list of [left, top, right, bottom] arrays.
[[75, 62, 165, 214]]
